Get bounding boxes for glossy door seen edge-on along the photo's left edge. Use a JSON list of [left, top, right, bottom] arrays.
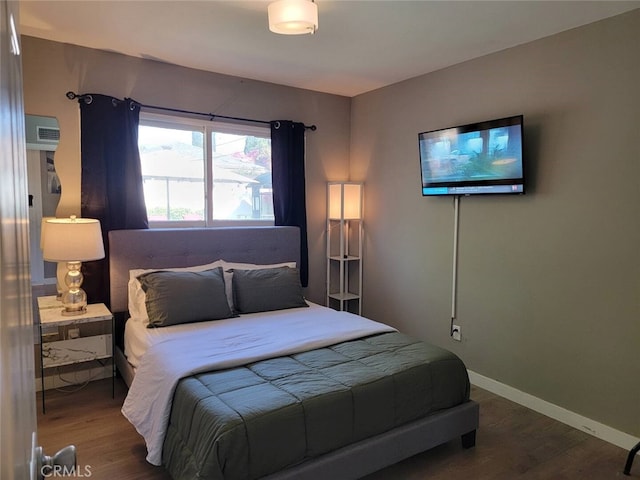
[[0, 0, 37, 480]]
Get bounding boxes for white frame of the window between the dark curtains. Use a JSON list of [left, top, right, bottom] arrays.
[[140, 112, 275, 228]]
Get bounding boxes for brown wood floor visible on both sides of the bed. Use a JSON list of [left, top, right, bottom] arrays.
[[37, 380, 640, 480]]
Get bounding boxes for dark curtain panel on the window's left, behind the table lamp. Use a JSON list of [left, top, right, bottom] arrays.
[[79, 94, 149, 305]]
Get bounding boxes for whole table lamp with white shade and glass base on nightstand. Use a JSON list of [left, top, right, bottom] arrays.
[[42, 215, 104, 315]]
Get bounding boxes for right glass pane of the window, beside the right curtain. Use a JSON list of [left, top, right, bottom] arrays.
[[211, 132, 273, 220]]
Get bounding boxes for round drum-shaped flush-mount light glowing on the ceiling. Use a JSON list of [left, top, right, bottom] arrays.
[[268, 0, 318, 35]]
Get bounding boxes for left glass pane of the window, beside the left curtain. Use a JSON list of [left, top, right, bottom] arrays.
[[138, 125, 205, 222]]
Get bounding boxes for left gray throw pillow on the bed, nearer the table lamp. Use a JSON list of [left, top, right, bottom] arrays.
[[138, 267, 234, 327]]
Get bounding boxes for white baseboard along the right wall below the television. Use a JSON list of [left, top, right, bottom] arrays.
[[468, 370, 640, 450]]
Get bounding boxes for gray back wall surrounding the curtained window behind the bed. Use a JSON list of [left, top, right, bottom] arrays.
[[22, 37, 351, 303]]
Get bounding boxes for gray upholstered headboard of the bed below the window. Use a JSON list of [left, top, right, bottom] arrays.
[[109, 227, 300, 313]]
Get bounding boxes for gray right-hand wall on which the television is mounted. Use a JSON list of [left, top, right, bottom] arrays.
[[350, 10, 640, 436]]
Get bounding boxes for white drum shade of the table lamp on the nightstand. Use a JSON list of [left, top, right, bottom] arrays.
[[42, 217, 104, 262]]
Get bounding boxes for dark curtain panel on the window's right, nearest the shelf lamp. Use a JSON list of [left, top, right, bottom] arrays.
[[270, 120, 309, 287]]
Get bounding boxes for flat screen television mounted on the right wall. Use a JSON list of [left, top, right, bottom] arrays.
[[418, 115, 524, 196]]
